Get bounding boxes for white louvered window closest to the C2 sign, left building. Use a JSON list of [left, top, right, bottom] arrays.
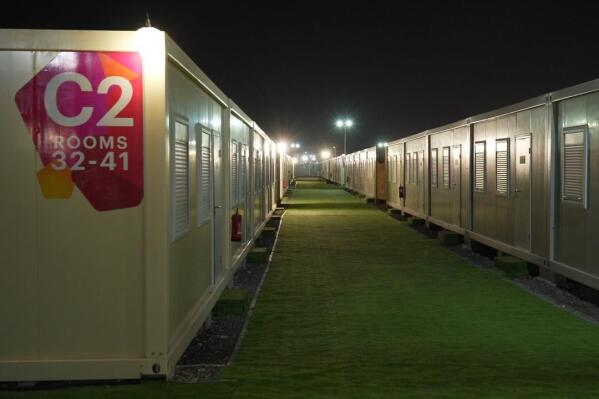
[[173, 121, 189, 238]]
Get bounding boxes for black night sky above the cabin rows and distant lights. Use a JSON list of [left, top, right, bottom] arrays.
[[0, 1, 599, 155]]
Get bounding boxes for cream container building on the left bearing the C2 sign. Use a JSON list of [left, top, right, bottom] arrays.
[[0, 28, 282, 381]]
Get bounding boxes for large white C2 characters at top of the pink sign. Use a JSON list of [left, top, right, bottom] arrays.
[[44, 72, 133, 127]]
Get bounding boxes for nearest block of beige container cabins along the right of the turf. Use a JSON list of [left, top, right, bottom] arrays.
[[337, 80, 599, 296]]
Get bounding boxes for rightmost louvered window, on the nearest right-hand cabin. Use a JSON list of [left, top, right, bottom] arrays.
[[562, 128, 587, 205]]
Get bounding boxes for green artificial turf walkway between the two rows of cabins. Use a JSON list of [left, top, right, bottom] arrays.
[[7, 181, 599, 399]]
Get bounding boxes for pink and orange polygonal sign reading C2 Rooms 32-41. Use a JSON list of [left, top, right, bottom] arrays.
[[15, 52, 143, 211]]
